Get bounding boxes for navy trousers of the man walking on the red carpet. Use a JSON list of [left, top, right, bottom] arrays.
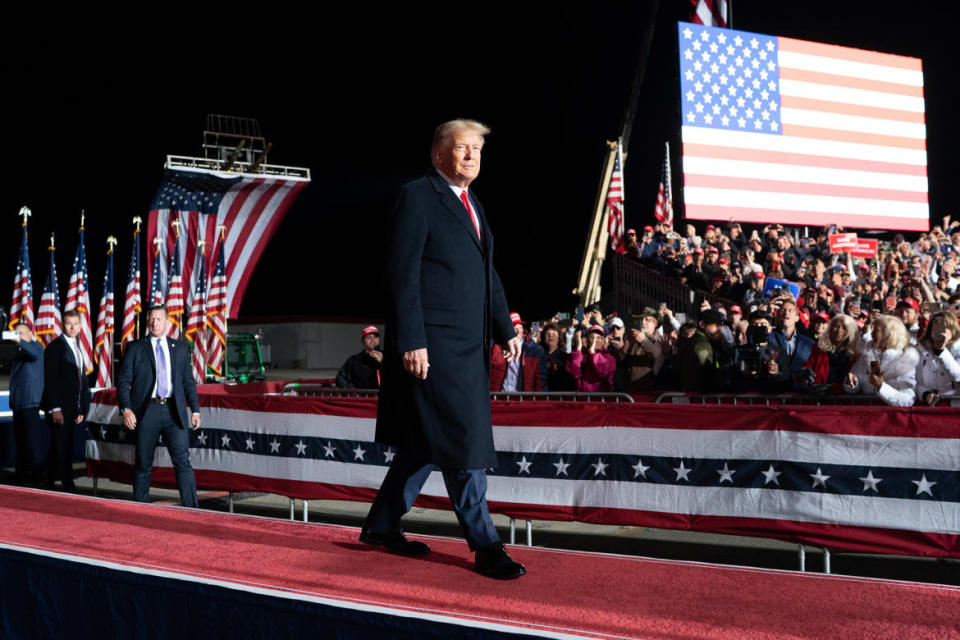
[[364, 451, 500, 551]]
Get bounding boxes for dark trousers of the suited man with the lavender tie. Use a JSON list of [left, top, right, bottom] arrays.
[[133, 402, 197, 508]]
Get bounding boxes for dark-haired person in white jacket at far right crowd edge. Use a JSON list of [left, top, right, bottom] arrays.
[[917, 311, 960, 405]]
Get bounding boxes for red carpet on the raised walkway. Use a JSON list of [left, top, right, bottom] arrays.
[[0, 487, 960, 640]]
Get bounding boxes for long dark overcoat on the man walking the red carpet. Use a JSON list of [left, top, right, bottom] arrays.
[[377, 169, 514, 469]]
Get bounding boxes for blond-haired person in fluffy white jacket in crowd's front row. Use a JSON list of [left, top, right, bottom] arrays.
[[843, 316, 920, 407]]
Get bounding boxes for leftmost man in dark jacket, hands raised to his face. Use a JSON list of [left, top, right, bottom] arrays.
[[10, 322, 43, 482]]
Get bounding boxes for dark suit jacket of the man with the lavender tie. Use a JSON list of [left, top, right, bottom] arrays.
[[117, 336, 200, 428]]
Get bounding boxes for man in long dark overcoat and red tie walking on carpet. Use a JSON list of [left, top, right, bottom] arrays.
[[360, 120, 526, 579]]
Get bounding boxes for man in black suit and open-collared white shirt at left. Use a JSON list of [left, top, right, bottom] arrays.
[[42, 311, 90, 491]]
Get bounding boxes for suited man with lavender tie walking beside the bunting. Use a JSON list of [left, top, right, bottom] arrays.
[[117, 306, 200, 507]]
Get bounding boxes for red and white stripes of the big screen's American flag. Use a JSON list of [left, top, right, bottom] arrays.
[[682, 33, 929, 231]]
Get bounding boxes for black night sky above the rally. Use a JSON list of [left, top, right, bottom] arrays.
[[0, 0, 960, 319]]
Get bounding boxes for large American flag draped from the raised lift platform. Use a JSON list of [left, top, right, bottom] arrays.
[[147, 168, 309, 318]]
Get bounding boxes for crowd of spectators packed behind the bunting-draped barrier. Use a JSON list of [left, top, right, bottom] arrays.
[[336, 217, 960, 406]]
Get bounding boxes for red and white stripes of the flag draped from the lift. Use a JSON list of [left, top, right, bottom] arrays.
[[147, 167, 310, 318]]
